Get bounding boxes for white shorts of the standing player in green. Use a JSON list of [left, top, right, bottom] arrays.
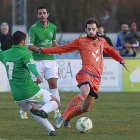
[[31, 60, 58, 81]]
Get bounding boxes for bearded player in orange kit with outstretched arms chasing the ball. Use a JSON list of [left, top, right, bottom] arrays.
[[40, 18, 129, 128]]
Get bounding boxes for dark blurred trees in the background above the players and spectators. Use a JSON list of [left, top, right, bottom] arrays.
[[0, 0, 140, 32]]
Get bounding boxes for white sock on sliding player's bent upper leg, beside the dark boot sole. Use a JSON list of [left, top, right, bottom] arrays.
[[40, 101, 58, 113]]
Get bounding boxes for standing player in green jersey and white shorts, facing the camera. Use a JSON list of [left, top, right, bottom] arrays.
[[27, 6, 61, 119]]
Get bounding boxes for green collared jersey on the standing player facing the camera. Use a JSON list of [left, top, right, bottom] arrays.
[[27, 21, 56, 60]]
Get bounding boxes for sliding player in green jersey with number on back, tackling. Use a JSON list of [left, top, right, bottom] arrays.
[[0, 31, 60, 136]]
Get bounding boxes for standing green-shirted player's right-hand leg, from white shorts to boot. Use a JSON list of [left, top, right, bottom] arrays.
[[44, 60, 61, 119]]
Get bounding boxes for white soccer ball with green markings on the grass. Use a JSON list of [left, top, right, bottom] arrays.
[[76, 117, 93, 133]]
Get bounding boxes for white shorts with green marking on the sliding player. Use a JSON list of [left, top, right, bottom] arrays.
[[15, 89, 52, 111]]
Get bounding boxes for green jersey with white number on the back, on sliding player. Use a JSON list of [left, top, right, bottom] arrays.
[[3, 45, 40, 101]]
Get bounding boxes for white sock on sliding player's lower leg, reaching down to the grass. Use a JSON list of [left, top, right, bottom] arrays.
[[32, 114, 55, 132]]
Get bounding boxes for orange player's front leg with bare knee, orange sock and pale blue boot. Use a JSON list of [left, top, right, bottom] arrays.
[[55, 84, 90, 128]]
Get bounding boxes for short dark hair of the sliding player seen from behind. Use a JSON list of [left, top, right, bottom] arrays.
[[12, 31, 26, 45]]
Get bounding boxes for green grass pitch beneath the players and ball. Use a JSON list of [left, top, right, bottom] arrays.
[[0, 92, 140, 140]]
